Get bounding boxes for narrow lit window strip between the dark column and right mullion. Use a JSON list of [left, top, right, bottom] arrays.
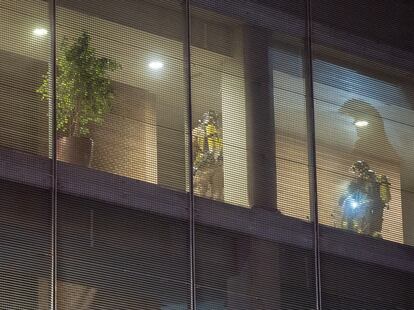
[[270, 44, 310, 221]]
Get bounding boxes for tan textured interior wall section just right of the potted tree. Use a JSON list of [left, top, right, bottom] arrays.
[[92, 83, 158, 184]]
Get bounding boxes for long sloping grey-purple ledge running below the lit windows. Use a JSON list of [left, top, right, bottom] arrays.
[[0, 149, 414, 274]]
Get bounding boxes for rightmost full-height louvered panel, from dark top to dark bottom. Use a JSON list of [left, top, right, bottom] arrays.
[[312, 0, 414, 310]]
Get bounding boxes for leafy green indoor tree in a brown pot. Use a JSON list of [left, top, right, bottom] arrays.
[[37, 32, 120, 166]]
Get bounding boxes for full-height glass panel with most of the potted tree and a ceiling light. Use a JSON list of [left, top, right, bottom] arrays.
[[57, 0, 190, 309]]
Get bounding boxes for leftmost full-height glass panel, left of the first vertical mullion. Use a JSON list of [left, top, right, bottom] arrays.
[[0, 0, 52, 309]]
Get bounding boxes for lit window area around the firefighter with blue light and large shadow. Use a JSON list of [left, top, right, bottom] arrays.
[[314, 34, 414, 243]]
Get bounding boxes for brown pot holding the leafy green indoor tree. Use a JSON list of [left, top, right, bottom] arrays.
[[56, 137, 93, 167]]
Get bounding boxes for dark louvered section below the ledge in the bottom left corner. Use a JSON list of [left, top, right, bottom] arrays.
[[0, 181, 51, 309]]
